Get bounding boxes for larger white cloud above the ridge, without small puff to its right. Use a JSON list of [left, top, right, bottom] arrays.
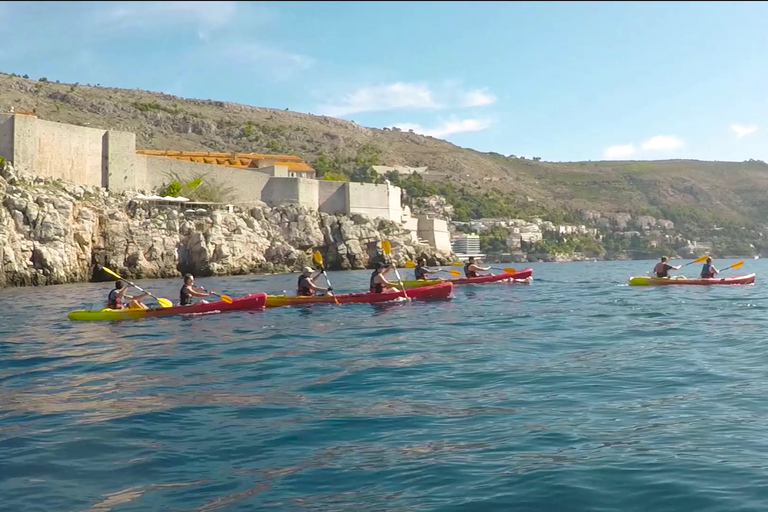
[[319, 82, 441, 117]]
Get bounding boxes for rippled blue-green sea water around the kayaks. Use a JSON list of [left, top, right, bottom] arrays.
[[0, 260, 768, 512]]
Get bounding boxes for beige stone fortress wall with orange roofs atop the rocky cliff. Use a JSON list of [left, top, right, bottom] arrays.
[[0, 114, 451, 252]]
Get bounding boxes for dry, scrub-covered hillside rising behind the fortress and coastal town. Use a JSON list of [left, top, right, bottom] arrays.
[[0, 75, 768, 231]]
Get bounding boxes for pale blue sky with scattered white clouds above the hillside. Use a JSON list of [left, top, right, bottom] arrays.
[[0, 2, 768, 161]]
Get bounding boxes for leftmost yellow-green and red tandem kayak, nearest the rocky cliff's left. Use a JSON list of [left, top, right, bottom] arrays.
[[69, 293, 267, 320]]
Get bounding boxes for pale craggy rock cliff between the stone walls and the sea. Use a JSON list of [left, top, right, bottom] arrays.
[[0, 164, 451, 286]]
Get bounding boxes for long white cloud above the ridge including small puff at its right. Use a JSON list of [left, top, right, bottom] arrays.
[[318, 82, 496, 117]]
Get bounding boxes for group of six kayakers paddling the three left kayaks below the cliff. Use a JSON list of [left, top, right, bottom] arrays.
[[107, 257, 498, 309]]
